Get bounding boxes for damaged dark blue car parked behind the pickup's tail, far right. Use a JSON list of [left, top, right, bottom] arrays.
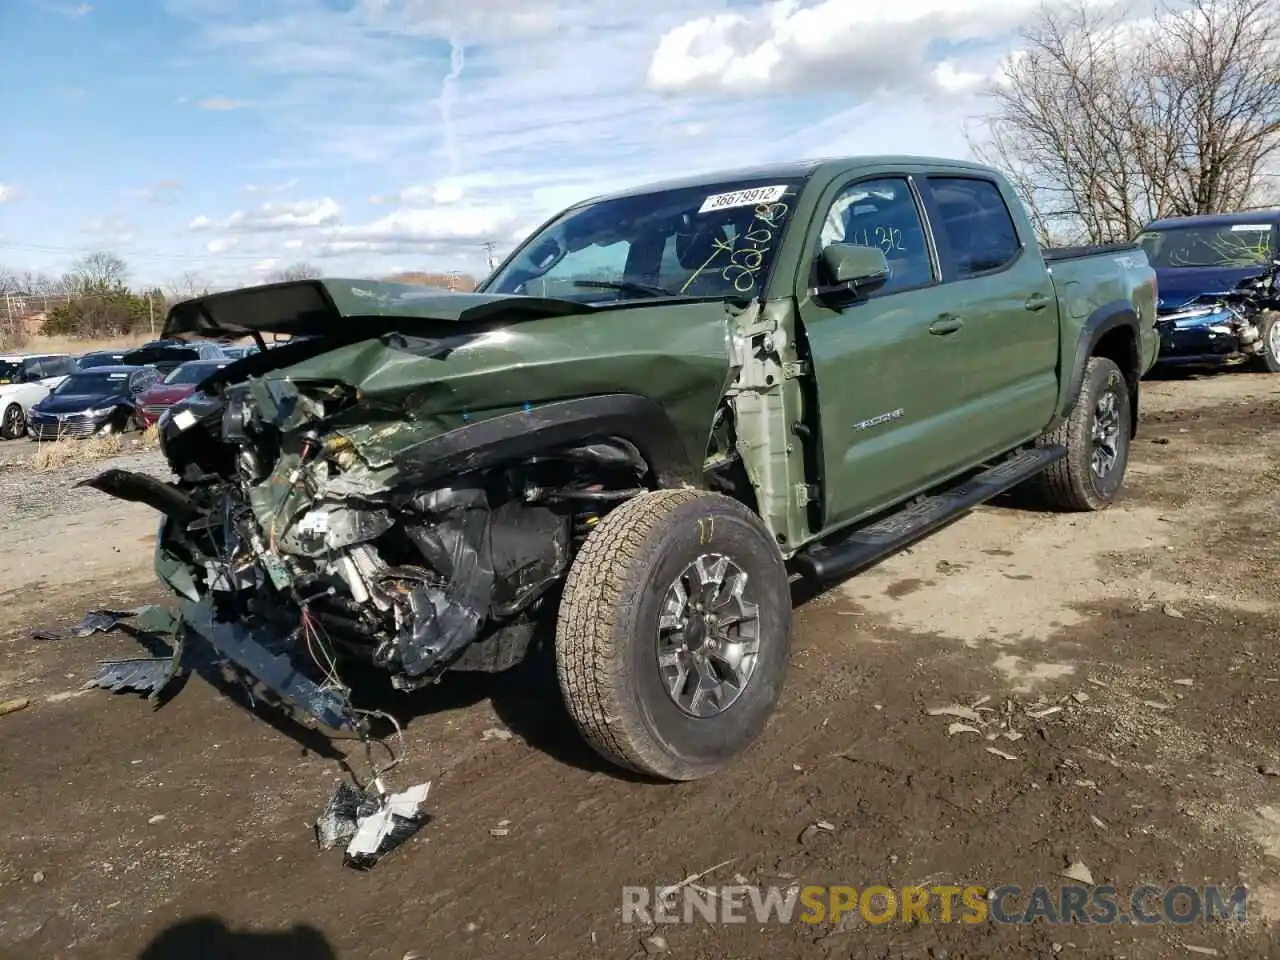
[[1137, 209, 1280, 372]]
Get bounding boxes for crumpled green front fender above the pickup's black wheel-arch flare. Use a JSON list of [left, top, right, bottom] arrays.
[[161, 294, 733, 527]]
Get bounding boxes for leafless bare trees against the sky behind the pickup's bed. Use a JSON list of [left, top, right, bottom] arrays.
[[969, 0, 1280, 243]]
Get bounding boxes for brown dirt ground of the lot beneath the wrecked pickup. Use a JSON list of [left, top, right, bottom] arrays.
[[0, 374, 1280, 960]]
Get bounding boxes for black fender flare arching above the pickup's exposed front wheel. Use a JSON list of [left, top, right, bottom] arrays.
[[393, 393, 701, 486]]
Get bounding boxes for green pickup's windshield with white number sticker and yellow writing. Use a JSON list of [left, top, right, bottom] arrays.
[[481, 178, 804, 301]]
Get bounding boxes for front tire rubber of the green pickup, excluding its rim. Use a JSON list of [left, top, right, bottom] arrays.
[[556, 489, 791, 781]]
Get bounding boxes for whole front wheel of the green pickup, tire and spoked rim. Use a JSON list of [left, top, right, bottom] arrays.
[[556, 490, 791, 781]]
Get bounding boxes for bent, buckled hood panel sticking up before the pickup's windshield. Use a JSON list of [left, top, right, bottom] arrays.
[[163, 279, 595, 338]]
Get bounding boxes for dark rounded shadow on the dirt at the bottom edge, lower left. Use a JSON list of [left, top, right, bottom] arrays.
[[137, 916, 338, 960]]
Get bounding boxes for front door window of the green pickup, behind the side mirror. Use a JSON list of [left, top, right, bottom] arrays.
[[814, 177, 933, 296]]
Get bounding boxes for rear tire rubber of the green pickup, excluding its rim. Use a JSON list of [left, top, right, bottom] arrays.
[[1032, 357, 1133, 512]]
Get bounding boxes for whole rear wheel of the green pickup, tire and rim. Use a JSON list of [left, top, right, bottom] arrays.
[[1034, 357, 1133, 511]]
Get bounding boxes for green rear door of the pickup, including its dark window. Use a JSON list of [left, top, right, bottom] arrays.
[[920, 173, 1059, 461]]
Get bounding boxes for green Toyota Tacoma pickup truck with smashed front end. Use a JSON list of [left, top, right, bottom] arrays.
[[88, 157, 1158, 780]]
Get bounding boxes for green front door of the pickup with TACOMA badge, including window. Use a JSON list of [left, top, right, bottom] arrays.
[[796, 174, 974, 535]]
